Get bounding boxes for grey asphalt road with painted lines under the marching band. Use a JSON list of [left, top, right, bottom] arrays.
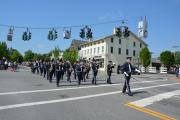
[[0, 69, 180, 120]]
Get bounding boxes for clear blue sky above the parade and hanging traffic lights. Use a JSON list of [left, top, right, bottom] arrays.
[[0, 0, 180, 57]]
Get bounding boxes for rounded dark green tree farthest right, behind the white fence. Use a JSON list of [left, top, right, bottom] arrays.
[[160, 51, 175, 70]]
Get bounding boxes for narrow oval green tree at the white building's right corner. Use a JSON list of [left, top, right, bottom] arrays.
[[140, 47, 151, 69]]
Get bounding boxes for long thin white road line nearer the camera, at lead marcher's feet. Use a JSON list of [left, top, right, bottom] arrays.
[[0, 83, 180, 110]]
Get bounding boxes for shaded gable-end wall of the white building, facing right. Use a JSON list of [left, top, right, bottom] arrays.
[[106, 36, 144, 68]]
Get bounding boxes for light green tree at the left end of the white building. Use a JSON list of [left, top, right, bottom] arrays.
[[63, 49, 78, 63]]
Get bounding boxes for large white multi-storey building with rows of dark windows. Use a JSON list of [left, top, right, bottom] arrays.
[[79, 32, 147, 71]]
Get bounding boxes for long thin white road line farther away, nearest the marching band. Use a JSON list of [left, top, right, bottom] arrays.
[[0, 79, 167, 96]]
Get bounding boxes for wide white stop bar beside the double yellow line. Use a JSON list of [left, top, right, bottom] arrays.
[[131, 90, 180, 107]]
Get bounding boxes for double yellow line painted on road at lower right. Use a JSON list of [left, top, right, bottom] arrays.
[[125, 103, 176, 120]]
